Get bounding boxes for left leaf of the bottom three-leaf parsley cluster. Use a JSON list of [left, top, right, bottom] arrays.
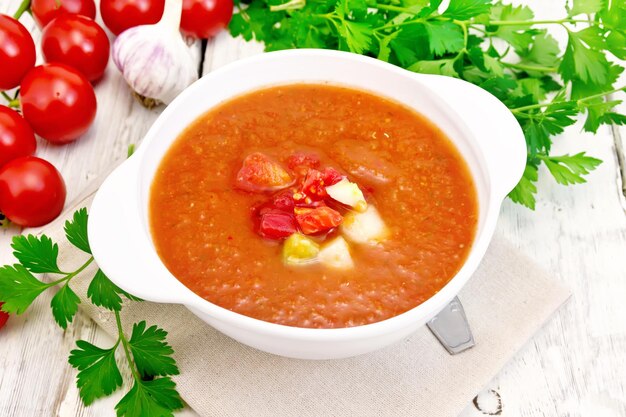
[[69, 340, 122, 404]]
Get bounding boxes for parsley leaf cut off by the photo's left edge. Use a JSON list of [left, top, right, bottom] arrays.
[[0, 264, 52, 314]]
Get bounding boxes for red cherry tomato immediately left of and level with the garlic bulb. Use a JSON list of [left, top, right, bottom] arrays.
[[41, 14, 110, 81]]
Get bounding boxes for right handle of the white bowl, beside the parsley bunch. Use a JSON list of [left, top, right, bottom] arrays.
[[415, 74, 527, 199]]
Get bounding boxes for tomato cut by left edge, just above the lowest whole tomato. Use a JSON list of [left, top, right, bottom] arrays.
[[0, 106, 37, 167]]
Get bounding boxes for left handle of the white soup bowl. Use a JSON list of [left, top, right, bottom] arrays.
[[88, 155, 193, 303]]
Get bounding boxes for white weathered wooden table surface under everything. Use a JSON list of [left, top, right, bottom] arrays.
[[0, 0, 626, 417]]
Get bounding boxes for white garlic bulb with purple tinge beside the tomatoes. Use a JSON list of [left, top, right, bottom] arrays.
[[113, 0, 198, 104]]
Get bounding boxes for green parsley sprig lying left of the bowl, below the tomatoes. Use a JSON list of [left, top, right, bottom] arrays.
[[0, 208, 183, 417]]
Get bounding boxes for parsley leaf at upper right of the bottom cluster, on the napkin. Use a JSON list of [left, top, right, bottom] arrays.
[[129, 321, 179, 376]]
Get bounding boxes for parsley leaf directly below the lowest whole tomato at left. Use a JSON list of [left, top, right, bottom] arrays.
[[11, 235, 62, 274]]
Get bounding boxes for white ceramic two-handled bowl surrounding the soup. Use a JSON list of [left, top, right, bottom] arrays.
[[89, 49, 526, 359]]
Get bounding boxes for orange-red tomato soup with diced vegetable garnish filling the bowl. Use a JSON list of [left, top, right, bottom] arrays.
[[150, 84, 478, 328]]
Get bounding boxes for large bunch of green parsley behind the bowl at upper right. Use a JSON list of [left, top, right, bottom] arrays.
[[230, 0, 626, 209]]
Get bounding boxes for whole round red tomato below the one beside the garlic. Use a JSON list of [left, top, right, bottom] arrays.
[[20, 64, 97, 143]]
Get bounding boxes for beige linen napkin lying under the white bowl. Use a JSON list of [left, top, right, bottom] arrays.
[[35, 175, 569, 417]]
